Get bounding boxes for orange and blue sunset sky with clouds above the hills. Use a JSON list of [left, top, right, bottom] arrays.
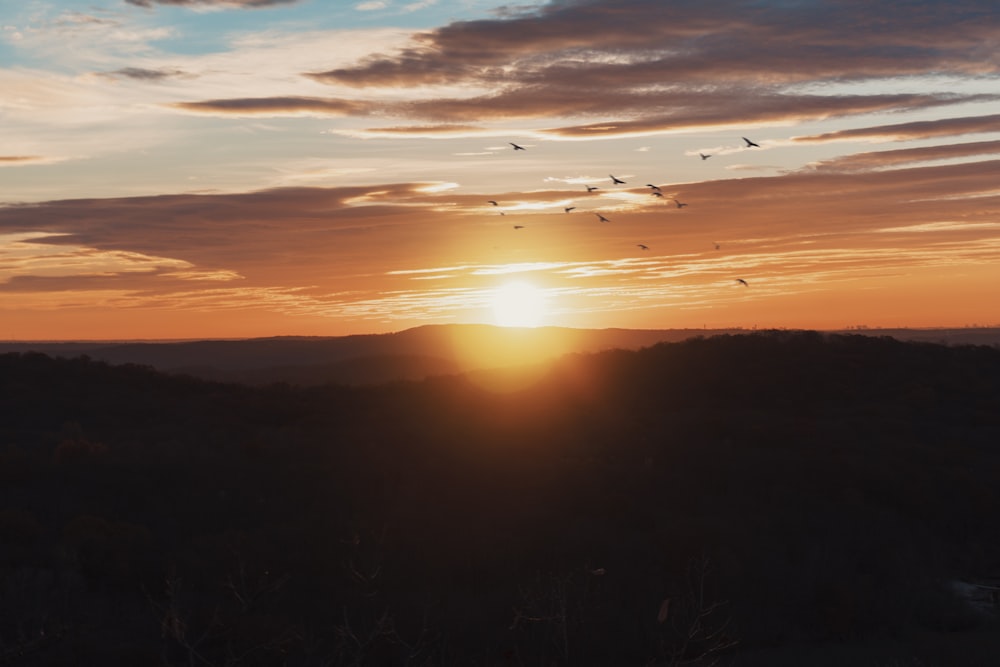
[[0, 0, 1000, 340]]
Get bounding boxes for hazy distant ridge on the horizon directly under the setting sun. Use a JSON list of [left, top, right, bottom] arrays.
[[0, 324, 1000, 386]]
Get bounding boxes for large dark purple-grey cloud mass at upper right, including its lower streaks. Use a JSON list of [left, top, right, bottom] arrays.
[[288, 0, 1000, 136]]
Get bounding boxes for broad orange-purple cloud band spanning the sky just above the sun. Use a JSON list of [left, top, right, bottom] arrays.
[[0, 161, 1000, 322]]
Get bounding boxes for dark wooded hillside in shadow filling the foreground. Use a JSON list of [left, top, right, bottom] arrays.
[[0, 332, 1000, 666]]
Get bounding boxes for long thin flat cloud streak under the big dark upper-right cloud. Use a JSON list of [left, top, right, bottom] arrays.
[[171, 87, 1000, 131]]
